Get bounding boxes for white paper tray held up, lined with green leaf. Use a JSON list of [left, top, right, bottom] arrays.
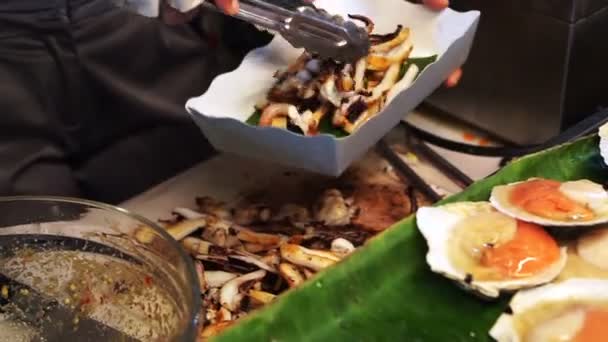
[[186, 0, 479, 176]]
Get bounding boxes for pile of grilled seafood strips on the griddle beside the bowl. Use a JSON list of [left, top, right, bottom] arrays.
[[158, 189, 373, 339]]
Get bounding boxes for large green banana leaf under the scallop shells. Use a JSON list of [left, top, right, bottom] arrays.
[[214, 136, 608, 342]]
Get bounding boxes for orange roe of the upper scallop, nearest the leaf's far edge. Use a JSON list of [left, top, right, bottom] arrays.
[[509, 179, 594, 221]]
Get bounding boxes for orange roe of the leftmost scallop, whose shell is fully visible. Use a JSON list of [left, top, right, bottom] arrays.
[[481, 221, 560, 279]]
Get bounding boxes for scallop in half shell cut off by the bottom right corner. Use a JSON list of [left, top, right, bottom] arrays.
[[490, 279, 608, 342]]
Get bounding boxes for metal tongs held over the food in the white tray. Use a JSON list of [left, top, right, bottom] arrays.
[[203, 0, 370, 62]]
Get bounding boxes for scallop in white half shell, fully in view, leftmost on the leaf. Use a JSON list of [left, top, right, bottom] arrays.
[[416, 202, 567, 298]]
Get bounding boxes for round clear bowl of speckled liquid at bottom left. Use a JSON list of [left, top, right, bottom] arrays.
[[0, 197, 201, 341]]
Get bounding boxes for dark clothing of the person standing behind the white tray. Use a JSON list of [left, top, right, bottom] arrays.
[[0, 0, 264, 203]]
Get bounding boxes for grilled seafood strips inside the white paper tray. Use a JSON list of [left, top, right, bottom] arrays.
[[256, 15, 428, 136]]
